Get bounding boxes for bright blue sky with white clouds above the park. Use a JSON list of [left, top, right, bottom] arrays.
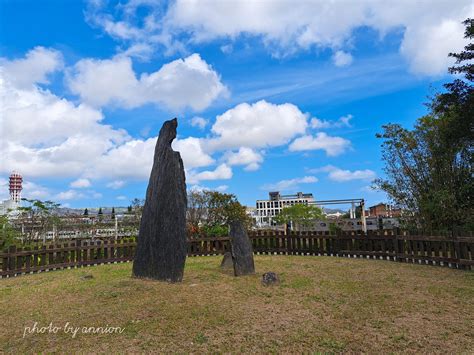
[[0, 0, 474, 207]]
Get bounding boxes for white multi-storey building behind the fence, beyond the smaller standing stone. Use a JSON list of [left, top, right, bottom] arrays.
[[254, 191, 314, 227]]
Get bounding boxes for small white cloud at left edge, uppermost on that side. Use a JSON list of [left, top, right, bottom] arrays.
[[0, 47, 63, 88]]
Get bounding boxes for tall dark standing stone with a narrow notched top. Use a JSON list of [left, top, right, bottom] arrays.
[[133, 118, 187, 282]]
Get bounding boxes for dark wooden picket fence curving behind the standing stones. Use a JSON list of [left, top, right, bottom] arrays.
[[0, 232, 474, 277]]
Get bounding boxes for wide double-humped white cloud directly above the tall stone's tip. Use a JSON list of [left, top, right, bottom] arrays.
[[66, 54, 227, 111]]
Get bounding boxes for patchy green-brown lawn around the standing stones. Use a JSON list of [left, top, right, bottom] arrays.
[[0, 256, 474, 353]]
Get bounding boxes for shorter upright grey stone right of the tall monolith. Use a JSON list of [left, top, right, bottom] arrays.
[[230, 221, 255, 276]]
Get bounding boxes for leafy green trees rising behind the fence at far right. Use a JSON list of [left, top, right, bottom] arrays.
[[375, 19, 474, 231]]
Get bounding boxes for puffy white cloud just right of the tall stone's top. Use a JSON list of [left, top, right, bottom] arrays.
[[207, 100, 307, 150]]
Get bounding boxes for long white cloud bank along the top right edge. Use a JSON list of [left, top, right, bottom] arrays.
[[165, 0, 474, 75]]
